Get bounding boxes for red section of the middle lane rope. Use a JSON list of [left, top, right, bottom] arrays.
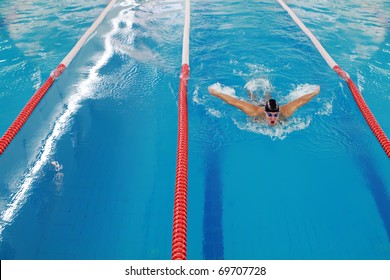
[[172, 64, 189, 260]]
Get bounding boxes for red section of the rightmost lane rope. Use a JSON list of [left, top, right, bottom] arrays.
[[333, 65, 390, 158]]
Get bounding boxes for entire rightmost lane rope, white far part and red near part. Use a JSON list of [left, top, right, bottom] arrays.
[[277, 0, 390, 158]]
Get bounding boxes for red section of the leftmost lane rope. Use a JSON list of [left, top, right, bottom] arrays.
[[0, 64, 66, 155]]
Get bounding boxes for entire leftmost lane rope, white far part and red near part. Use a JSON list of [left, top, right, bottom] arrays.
[[0, 0, 116, 156]]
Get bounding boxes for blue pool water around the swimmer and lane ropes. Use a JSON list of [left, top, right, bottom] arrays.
[[0, 0, 390, 259]]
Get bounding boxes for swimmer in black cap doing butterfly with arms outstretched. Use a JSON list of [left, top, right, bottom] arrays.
[[209, 86, 320, 126]]
